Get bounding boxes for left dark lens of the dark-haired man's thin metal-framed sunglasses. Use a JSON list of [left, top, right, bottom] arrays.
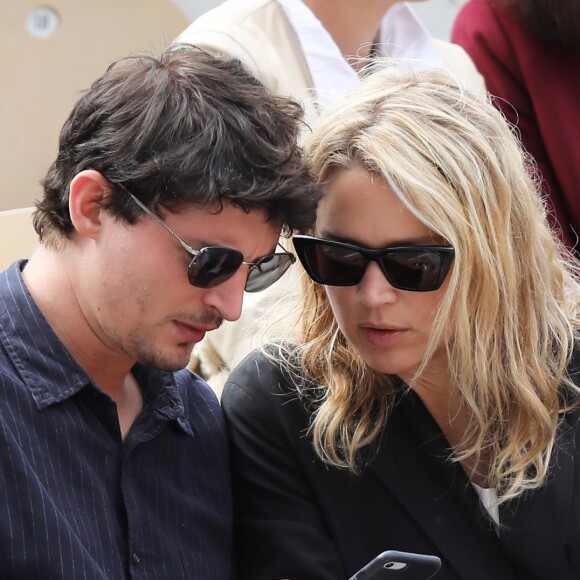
[[187, 247, 244, 288]]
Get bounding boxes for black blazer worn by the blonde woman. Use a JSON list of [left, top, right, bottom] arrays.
[[222, 353, 580, 580]]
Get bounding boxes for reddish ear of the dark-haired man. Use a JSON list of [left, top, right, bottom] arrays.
[[68, 169, 112, 238]]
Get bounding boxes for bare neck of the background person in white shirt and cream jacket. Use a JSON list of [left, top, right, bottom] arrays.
[[303, 0, 398, 58]]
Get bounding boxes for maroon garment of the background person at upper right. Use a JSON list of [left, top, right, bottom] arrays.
[[452, 0, 580, 250]]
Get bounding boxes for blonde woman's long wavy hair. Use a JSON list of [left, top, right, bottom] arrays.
[[276, 65, 580, 503]]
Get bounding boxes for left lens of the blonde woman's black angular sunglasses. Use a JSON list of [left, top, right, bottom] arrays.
[[296, 243, 365, 286]]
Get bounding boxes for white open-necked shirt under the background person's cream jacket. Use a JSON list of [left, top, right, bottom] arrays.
[[278, 0, 444, 108]]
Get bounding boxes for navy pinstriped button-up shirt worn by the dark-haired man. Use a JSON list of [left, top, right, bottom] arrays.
[[0, 262, 232, 580]]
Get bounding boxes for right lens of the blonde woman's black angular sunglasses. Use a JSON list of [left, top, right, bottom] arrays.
[[380, 250, 442, 292]]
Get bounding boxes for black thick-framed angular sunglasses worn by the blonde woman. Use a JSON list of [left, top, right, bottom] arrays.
[[293, 236, 455, 292]]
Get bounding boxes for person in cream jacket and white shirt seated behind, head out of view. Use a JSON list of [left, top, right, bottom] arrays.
[[178, 0, 485, 392]]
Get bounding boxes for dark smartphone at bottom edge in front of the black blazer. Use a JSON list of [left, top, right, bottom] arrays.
[[349, 550, 441, 580]]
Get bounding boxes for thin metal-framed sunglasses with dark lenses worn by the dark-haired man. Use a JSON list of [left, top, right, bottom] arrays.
[[115, 183, 296, 292]]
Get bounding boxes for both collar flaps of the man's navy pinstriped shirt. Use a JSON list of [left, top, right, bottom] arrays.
[[0, 260, 185, 432]]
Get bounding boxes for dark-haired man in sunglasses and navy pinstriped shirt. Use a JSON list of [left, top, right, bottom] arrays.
[[0, 45, 318, 580]]
